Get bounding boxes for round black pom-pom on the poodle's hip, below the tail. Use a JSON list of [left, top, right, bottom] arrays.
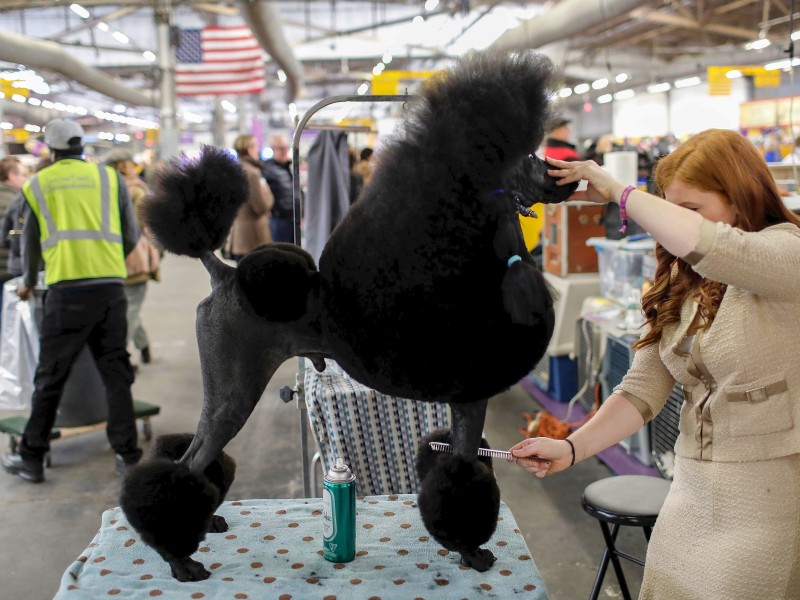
[[236, 244, 319, 322]]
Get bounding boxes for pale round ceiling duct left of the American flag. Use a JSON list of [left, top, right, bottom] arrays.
[[0, 31, 158, 107]]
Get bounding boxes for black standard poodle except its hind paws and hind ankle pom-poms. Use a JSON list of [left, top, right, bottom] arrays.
[[123, 52, 575, 578]]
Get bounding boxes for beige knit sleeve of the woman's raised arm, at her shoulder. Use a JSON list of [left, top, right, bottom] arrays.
[[685, 220, 800, 302]]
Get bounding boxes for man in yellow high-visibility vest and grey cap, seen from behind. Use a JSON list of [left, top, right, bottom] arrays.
[[2, 119, 142, 483]]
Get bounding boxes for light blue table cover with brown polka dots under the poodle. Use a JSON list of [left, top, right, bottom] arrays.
[[54, 494, 547, 600]]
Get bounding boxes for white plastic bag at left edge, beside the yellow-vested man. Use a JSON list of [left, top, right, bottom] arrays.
[[0, 277, 39, 410]]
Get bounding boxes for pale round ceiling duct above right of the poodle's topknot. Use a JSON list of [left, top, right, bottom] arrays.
[[492, 0, 646, 50]]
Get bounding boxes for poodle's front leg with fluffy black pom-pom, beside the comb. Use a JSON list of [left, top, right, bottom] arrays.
[[417, 400, 500, 571]]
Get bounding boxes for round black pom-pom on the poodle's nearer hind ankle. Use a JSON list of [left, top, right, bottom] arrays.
[[120, 458, 219, 557]]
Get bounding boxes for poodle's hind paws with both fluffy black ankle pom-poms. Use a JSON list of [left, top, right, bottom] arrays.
[[120, 433, 236, 581]]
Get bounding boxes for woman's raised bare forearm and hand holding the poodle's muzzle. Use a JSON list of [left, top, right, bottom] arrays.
[[547, 158, 703, 258]]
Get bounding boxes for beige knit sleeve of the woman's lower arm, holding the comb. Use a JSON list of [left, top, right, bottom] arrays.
[[613, 327, 675, 423]]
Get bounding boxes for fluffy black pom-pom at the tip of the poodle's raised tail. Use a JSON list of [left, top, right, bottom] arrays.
[[139, 146, 248, 258]]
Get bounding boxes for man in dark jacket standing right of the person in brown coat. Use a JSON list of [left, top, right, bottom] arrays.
[[262, 134, 301, 243]]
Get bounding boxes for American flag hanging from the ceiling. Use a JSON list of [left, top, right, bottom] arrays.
[[175, 25, 265, 96]]
